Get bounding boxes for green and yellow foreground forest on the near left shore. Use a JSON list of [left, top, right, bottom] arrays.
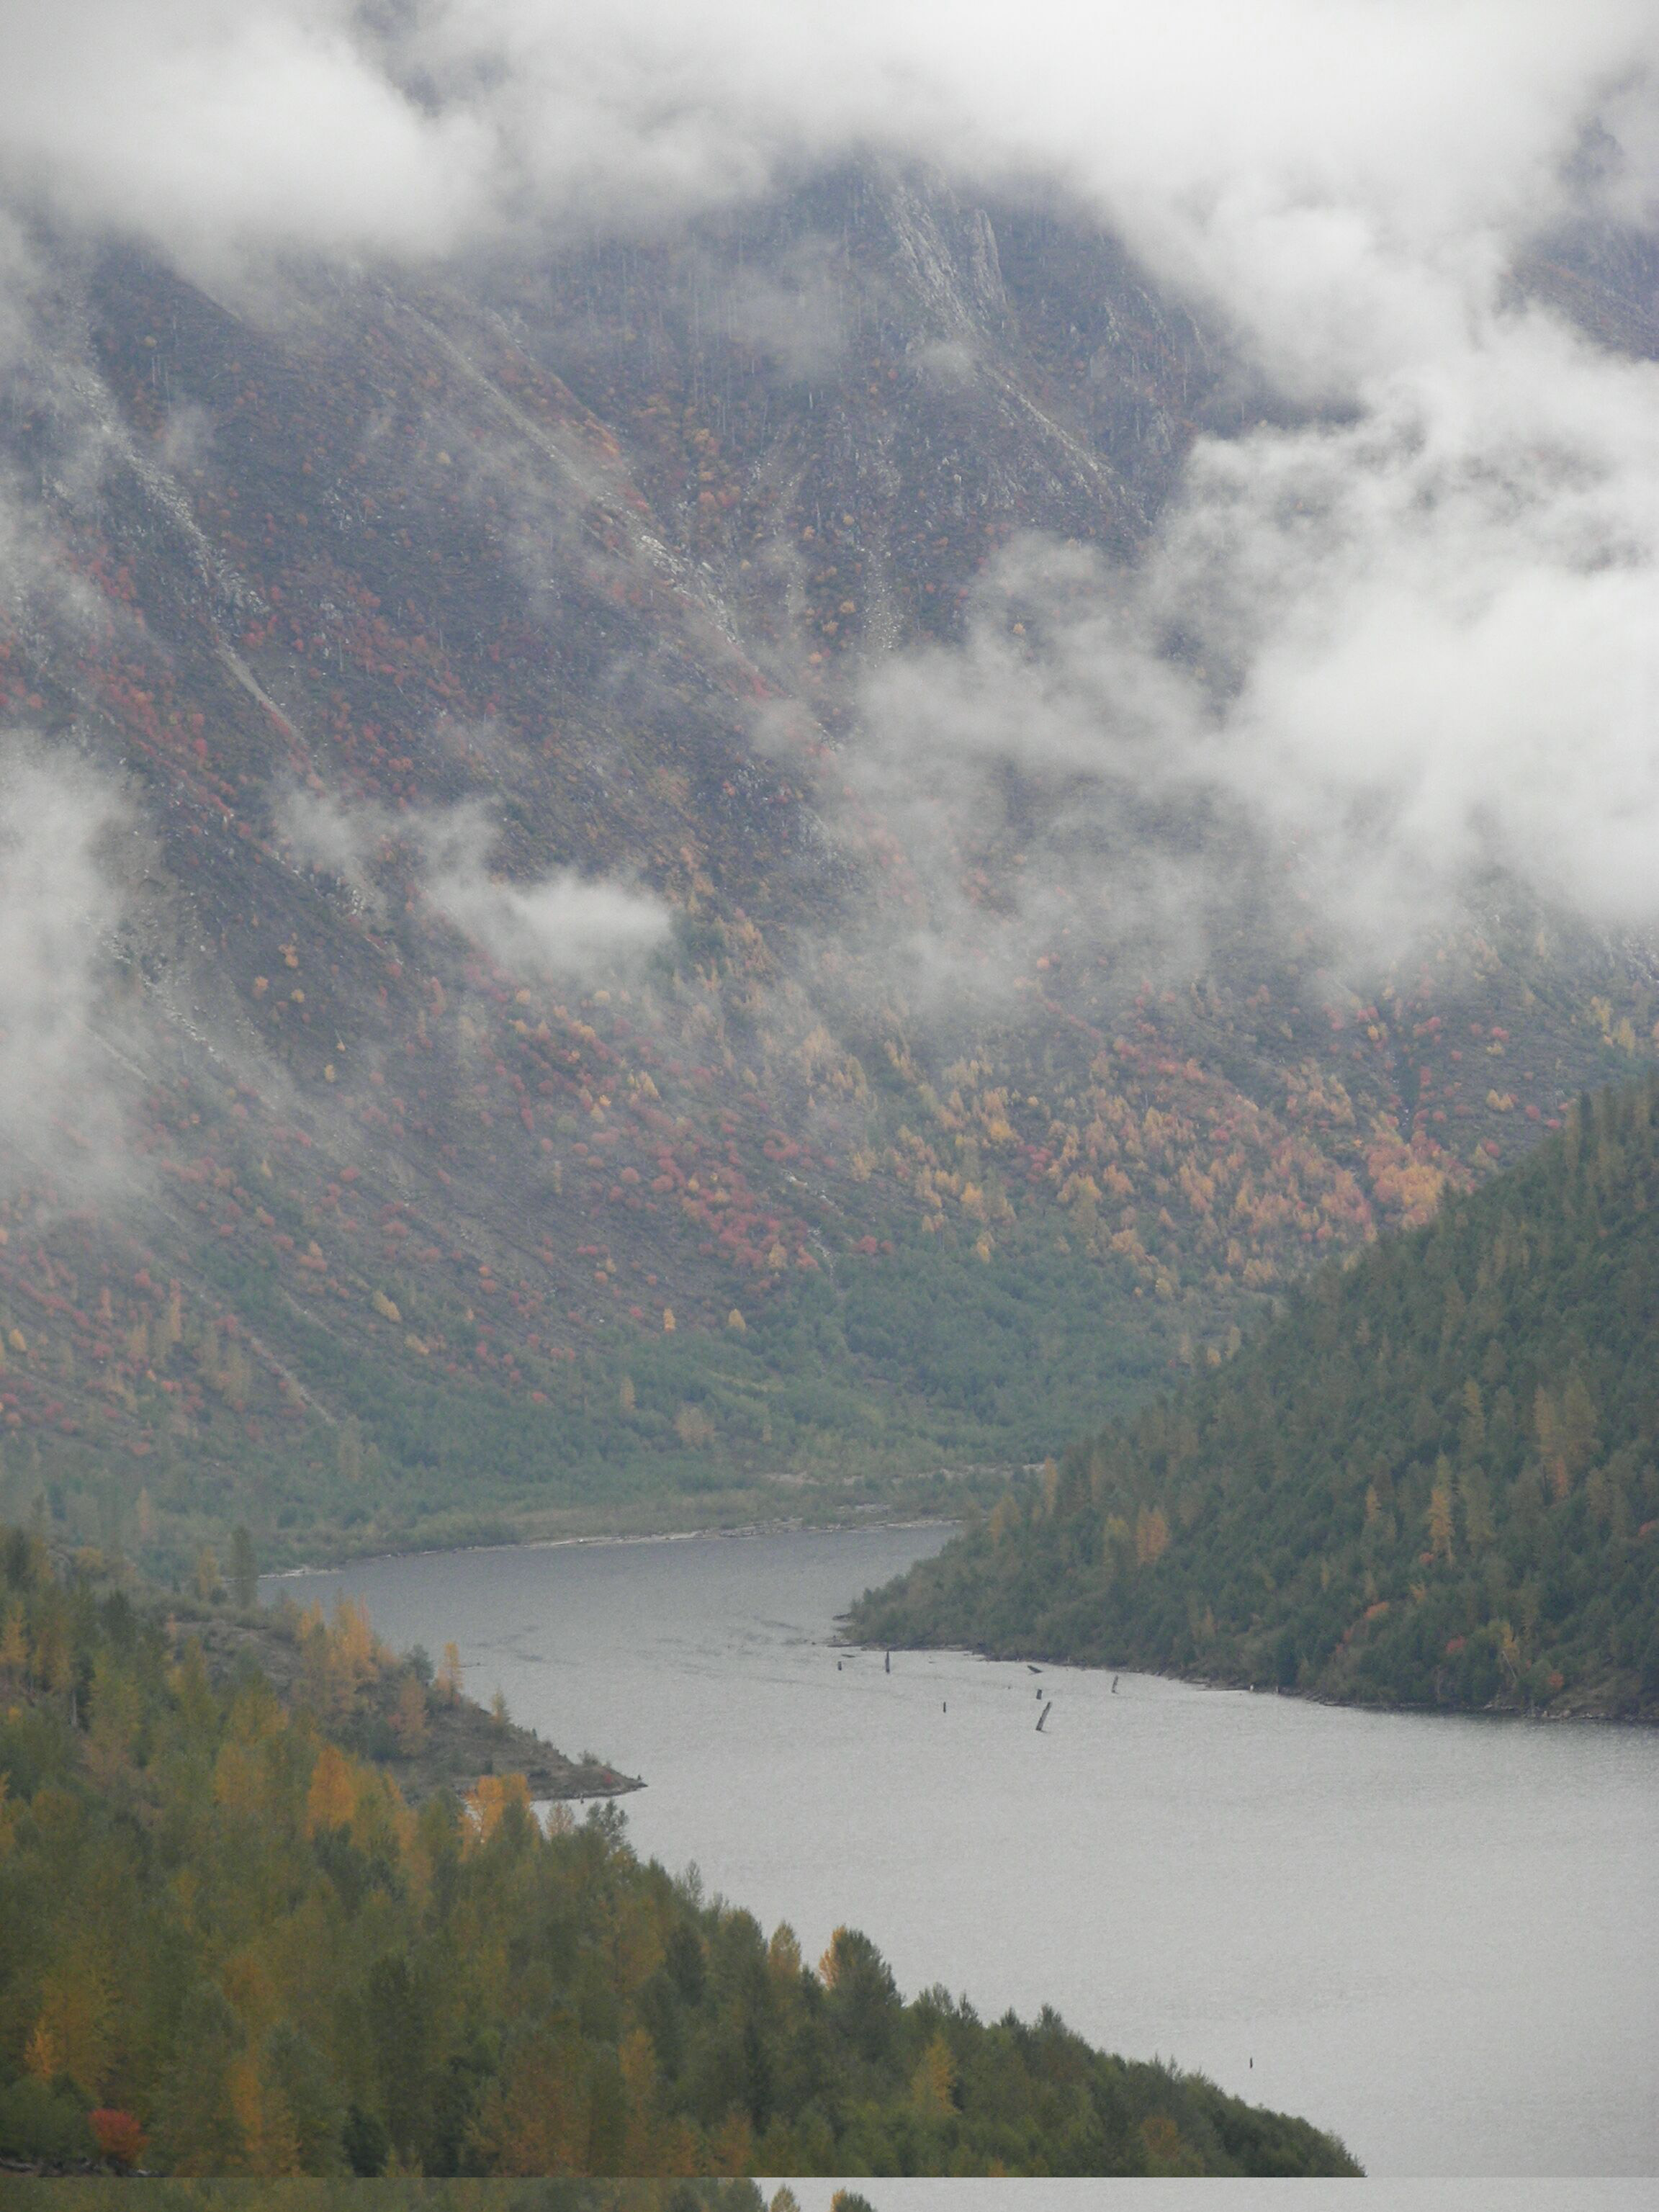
[[0, 1531, 1352, 2175]]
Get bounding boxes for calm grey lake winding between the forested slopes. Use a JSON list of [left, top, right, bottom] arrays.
[[285, 1529, 1659, 2201]]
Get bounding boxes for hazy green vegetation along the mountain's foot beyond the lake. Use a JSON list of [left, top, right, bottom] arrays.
[[0, 1159, 1190, 1575]]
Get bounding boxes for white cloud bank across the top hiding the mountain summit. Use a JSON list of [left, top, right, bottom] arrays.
[[0, 0, 1659, 336]]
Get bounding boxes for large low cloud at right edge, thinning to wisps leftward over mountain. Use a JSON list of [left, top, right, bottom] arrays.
[[850, 263, 1659, 960]]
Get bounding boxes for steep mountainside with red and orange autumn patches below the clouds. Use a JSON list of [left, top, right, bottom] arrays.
[[0, 163, 1659, 1557]]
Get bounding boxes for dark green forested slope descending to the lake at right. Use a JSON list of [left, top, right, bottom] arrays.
[[854, 1082, 1659, 1719]]
